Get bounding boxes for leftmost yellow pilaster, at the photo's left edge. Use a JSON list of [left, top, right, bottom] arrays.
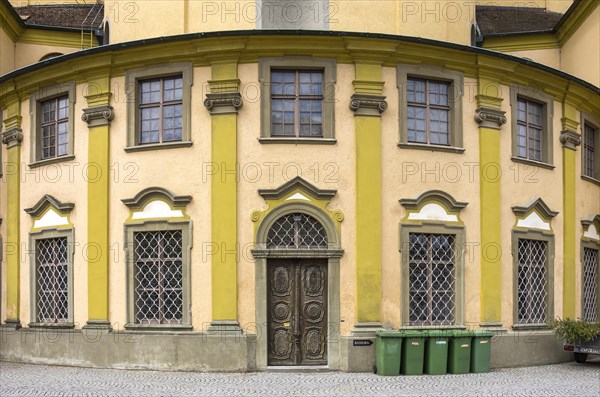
[[2, 100, 23, 329]]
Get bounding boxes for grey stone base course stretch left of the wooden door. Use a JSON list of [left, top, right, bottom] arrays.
[[0, 328, 256, 372]]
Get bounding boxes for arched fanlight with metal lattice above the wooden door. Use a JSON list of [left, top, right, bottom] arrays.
[[267, 213, 327, 249]]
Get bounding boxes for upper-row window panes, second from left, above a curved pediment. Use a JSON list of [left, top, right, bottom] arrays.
[[139, 75, 183, 144]]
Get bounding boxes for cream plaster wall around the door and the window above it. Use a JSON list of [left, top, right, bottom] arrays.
[[238, 64, 356, 333]]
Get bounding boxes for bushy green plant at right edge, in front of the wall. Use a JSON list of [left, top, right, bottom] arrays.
[[549, 318, 600, 363]]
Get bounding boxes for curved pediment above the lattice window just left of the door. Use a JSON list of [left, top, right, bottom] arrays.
[[121, 187, 192, 223]]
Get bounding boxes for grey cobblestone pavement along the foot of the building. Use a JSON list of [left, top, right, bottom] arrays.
[[0, 359, 600, 397]]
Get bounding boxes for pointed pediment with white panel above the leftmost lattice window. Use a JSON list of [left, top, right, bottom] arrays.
[[25, 194, 75, 231]]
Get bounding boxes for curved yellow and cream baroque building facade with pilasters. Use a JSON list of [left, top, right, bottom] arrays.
[[0, 0, 600, 371]]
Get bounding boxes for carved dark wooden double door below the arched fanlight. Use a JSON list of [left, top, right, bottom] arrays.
[[267, 259, 327, 365]]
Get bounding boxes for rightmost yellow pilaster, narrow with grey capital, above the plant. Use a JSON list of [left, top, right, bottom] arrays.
[[560, 100, 581, 319]]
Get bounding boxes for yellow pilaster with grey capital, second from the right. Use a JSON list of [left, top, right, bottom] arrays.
[[475, 65, 509, 327]]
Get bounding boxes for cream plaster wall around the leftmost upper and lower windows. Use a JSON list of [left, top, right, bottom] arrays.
[[20, 86, 92, 328]]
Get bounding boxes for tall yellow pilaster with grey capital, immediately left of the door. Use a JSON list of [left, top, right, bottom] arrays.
[[204, 60, 242, 332]]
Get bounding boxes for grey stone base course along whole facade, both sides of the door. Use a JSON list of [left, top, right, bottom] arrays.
[[0, 328, 573, 372]]
